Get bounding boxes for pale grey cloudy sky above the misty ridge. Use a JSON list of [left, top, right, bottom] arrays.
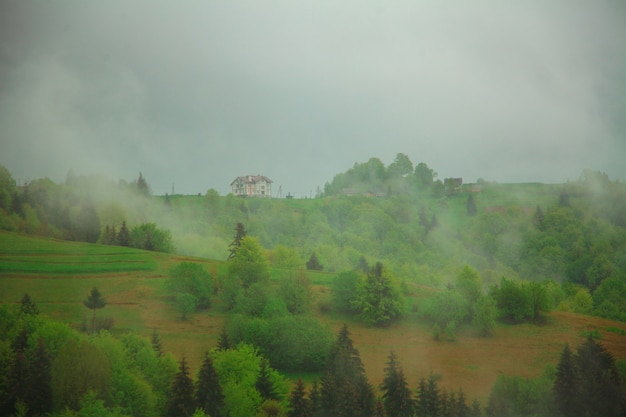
[[0, 0, 626, 197]]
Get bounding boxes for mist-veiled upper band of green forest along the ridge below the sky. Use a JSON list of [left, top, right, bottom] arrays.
[[0, 158, 626, 320]]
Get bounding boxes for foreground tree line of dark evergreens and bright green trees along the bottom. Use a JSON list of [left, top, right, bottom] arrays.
[[0, 294, 626, 417]]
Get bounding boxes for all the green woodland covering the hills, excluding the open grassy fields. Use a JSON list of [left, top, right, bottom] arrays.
[[0, 154, 626, 417]]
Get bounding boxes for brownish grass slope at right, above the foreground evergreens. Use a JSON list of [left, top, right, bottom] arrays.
[[320, 312, 626, 403]]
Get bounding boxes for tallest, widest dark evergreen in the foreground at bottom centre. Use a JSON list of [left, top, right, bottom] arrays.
[[320, 325, 375, 417]]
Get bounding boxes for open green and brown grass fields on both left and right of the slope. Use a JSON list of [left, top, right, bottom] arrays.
[[0, 232, 626, 401]]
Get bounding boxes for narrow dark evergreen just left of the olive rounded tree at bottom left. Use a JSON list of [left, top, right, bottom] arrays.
[[24, 339, 52, 416]]
